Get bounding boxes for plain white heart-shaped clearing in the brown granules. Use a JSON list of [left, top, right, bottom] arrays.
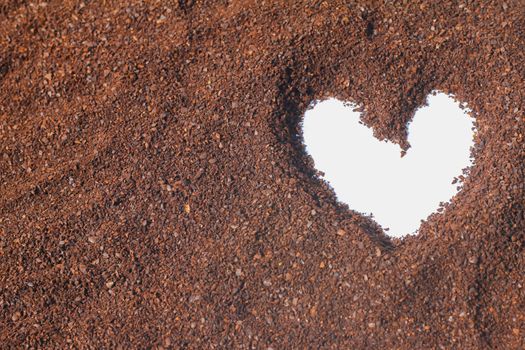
[[303, 93, 474, 237]]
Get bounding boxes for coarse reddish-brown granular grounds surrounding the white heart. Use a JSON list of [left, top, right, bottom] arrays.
[[0, 0, 525, 349]]
